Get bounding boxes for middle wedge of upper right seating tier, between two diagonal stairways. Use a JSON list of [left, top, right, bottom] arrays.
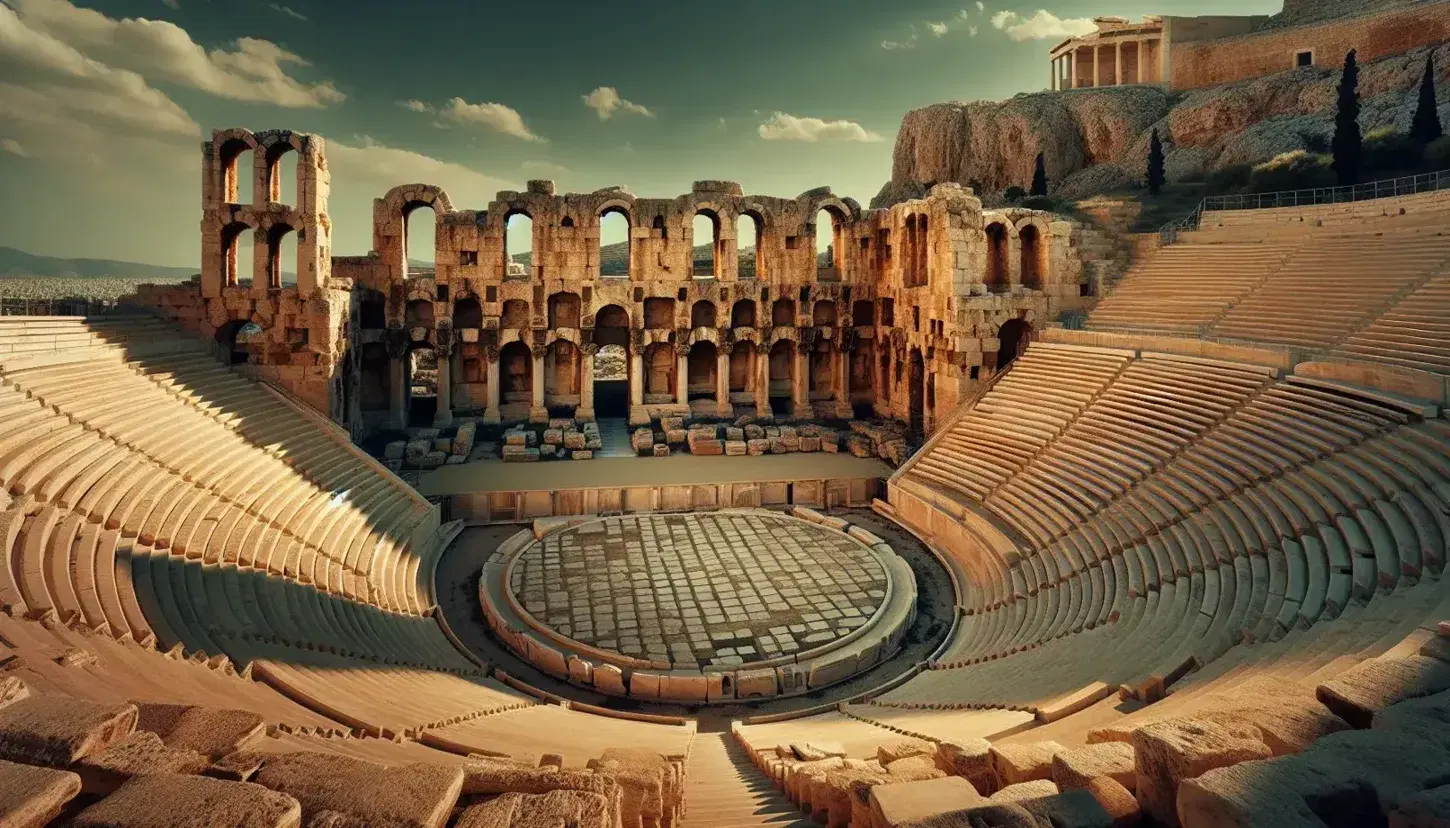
[[1206, 232, 1450, 349]]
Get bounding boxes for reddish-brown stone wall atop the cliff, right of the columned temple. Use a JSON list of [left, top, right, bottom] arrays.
[[1169, 1, 1450, 90]]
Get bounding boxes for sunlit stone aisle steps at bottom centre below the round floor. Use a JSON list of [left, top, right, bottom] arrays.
[[682, 732, 815, 828]]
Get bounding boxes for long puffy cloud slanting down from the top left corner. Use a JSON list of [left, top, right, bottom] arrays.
[[7, 0, 347, 109]]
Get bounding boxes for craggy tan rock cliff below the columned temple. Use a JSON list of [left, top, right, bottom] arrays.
[[871, 44, 1450, 207]]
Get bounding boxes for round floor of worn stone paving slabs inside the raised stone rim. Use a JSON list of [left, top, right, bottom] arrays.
[[509, 513, 886, 667]]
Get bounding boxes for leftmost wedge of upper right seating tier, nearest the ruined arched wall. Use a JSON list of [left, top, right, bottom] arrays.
[[1088, 242, 1298, 335]]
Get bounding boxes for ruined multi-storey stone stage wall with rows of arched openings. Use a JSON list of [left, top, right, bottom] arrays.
[[139, 129, 1111, 436]]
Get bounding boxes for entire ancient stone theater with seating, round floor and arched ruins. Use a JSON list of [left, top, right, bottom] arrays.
[[0, 3, 1450, 828]]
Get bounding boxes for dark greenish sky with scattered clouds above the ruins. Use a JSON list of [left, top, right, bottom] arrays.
[[0, 0, 1282, 267]]
